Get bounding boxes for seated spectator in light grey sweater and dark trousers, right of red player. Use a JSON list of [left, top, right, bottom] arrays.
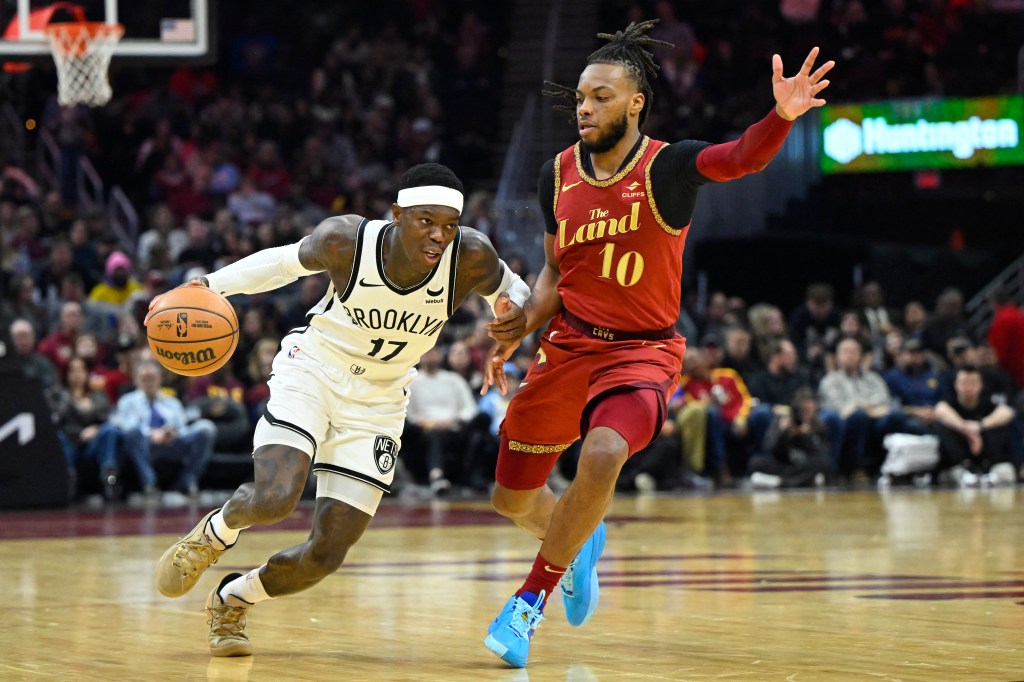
[[818, 339, 894, 485]]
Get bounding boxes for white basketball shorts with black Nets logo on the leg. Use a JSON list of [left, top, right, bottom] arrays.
[[253, 334, 413, 516]]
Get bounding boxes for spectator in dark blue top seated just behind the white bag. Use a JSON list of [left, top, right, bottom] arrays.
[[885, 337, 942, 434]]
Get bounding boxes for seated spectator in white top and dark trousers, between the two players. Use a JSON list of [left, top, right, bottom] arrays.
[[402, 347, 478, 495]]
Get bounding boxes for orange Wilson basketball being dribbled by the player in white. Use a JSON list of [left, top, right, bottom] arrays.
[[145, 287, 239, 377]]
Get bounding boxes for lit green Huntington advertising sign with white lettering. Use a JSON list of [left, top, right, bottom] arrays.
[[821, 95, 1024, 173]]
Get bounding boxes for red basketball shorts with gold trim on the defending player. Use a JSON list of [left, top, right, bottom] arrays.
[[497, 315, 686, 491]]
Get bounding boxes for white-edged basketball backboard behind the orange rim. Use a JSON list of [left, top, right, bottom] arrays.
[[0, 0, 216, 61]]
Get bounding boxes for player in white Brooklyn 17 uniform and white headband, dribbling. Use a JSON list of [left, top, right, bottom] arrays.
[[151, 164, 529, 656]]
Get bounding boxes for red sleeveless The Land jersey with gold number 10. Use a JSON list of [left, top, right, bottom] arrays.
[[554, 136, 689, 332]]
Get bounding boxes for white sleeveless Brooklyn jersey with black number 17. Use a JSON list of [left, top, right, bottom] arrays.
[[282, 219, 462, 384]]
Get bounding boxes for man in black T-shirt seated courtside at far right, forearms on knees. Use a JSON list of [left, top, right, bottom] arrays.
[[935, 366, 1017, 486]]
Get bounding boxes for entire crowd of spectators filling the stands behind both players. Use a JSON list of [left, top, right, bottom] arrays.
[[0, 0, 1024, 499]]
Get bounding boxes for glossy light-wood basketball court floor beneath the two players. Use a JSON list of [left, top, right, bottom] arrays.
[[0, 488, 1024, 682]]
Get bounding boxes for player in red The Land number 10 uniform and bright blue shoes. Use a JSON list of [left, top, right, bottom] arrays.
[[484, 22, 835, 668]]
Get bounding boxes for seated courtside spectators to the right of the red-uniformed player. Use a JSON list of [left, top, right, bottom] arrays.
[[622, 282, 1024, 489]]
